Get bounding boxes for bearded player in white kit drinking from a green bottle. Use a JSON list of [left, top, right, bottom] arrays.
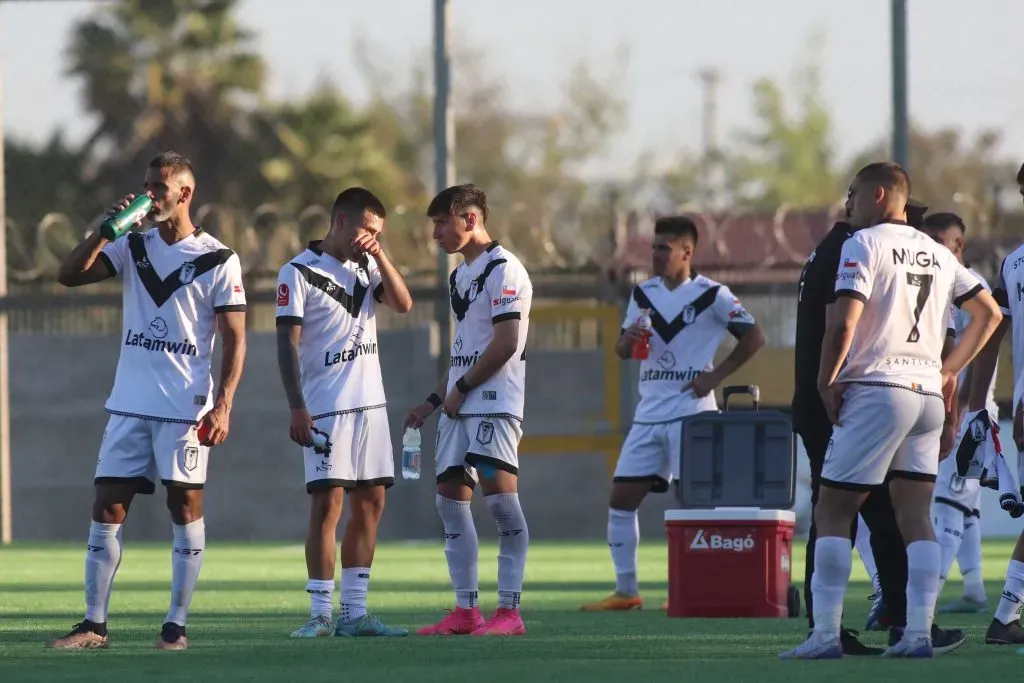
[[48, 152, 246, 650]]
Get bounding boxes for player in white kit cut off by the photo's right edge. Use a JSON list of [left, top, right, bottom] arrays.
[[968, 160, 1024, 645]]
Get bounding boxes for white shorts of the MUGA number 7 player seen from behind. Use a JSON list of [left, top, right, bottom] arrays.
[[821, 383, 945, 490]]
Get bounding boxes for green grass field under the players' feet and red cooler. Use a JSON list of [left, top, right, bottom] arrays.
[[0, 539, 1024, 683]]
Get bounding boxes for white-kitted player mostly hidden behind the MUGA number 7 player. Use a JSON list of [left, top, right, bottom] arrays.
[[922, 213, 998, 613]]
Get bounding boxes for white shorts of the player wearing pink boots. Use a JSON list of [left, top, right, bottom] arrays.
[[434, 415, 522, 486]]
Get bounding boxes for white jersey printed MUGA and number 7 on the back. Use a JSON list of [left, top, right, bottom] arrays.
[[836, 223, 982, 396]]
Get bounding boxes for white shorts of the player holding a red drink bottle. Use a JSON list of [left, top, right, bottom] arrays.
[[611, 420, 683, 494]]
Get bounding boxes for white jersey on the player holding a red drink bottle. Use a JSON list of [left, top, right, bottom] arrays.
[[623, 272, 754, 424]]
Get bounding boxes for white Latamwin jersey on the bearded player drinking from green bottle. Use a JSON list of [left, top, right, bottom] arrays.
[[100, 227, 246, 423]]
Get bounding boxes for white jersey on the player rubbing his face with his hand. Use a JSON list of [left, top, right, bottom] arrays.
[[278, 242, 387, 420]]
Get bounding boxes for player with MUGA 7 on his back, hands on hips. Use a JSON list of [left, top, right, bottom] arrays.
[[780, 163, 999, 659]]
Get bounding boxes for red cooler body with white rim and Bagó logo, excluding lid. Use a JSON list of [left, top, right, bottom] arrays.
[[665, 508, 800, 618]]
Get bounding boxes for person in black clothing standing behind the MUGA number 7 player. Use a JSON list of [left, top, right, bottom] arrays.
[[793, 200, 964, 654]]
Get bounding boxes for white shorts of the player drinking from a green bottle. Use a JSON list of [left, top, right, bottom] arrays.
[[95, 415, 210, 494]]
